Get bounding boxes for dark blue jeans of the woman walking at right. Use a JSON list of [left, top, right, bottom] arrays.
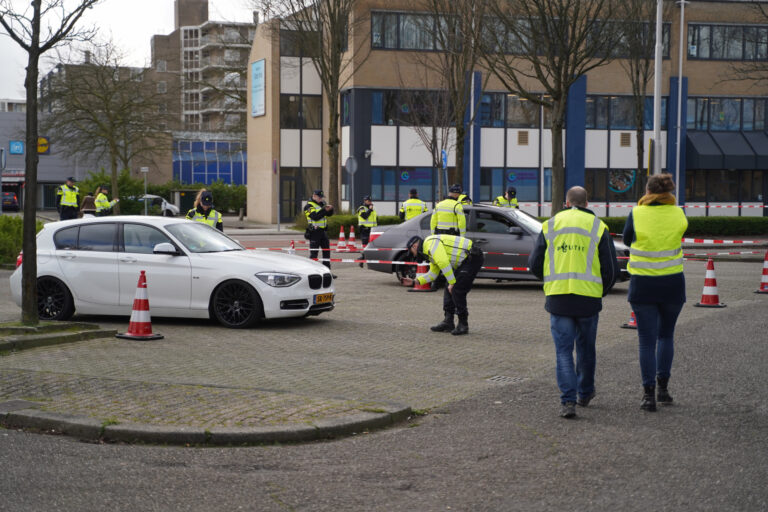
[[630, 302, 683, 386]]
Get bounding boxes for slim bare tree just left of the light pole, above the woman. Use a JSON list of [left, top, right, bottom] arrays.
[[614, 0, 672, 180]]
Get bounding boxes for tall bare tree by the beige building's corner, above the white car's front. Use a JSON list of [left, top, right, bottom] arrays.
[[256, 0, 370, 205]]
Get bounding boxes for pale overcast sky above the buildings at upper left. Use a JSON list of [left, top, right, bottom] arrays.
[[0, 0, 253, 99]]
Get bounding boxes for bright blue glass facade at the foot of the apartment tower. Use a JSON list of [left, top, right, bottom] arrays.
[[173, 140, 247, 185]]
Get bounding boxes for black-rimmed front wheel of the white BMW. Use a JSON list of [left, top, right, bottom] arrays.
[[211, 280, 264, 329]]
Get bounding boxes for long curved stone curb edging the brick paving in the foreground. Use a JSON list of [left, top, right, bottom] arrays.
[[0, 400, 411, 446]]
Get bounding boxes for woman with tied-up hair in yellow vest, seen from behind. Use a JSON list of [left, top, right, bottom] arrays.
[[624, 173, 688, 411]]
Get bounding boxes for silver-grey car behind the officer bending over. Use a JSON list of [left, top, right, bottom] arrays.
[[363, 204, 629, 281]]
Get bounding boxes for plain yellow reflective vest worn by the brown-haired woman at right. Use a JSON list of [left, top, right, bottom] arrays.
[[627, 205, 688, 276]]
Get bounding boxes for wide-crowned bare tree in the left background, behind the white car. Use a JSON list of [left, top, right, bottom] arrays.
[[41, 43, 176, 208]]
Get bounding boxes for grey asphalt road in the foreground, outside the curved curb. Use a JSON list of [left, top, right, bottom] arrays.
[[0, 246, 768, 512]]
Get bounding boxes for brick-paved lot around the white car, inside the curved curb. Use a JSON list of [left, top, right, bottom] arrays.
[[0, 254, 763, 427]]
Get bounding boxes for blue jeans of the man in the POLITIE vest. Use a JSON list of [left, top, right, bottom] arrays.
[[550, 315, 598, 404]]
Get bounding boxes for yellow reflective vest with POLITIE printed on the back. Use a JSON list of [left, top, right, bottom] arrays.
[[542, 208, 608, 298]]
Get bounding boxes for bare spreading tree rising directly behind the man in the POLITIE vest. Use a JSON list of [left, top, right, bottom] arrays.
[[481, 0, 620, 214]]
